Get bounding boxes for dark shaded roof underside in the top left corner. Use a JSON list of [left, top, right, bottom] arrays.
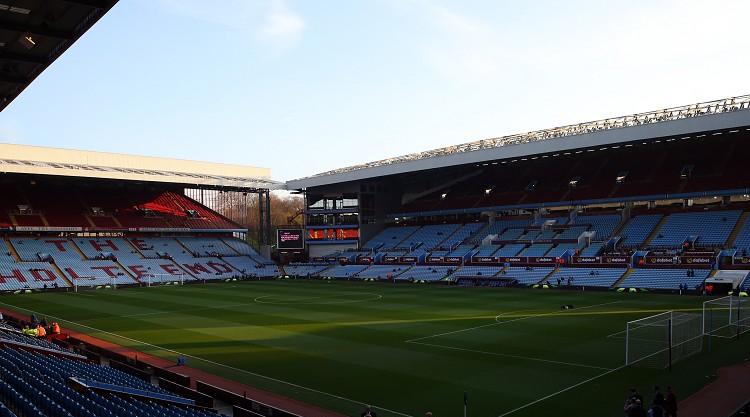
[[0, 0, 118, 111]]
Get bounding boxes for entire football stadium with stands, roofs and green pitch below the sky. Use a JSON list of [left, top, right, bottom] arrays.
[[0, 0, 750, 417]]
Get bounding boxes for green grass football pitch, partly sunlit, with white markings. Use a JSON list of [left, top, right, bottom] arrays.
[[0, 280, 750, 417]]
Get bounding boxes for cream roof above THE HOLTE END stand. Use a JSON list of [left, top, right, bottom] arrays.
[[0, 143, 284, 190]]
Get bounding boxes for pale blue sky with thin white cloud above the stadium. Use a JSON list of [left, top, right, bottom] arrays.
[[0, 0, 750, 180]]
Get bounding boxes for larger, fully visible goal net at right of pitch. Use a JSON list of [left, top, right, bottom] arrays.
[[625, 311, 703, 369]]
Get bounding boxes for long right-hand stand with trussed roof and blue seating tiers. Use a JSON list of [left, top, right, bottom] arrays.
[[287, 96, 750, 290]]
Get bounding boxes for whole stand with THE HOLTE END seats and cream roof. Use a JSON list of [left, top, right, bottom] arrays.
[[0, 144, 282, 292]]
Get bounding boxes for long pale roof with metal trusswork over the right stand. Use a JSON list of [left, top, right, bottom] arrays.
[[287, 95, 750, 189]]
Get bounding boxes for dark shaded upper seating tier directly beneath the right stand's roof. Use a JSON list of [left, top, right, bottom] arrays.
[[396, 131, 750, 213]]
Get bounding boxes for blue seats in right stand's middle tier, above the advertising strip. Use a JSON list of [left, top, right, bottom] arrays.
[[356, 210, 750, 257]]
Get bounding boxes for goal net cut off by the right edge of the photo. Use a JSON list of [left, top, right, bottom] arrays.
[[703, 295, 750, 338]]
